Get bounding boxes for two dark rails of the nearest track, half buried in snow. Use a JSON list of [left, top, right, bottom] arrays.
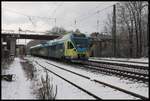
[[32, 61, 148, 99]]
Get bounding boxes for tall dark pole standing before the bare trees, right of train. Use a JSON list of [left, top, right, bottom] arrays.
[[112, 5, 117, 57]]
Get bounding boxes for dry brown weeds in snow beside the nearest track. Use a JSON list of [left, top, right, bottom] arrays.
[[20, 57, 57, 100]]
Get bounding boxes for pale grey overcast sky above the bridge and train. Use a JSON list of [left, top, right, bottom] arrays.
[[2, 1, 117, 44]]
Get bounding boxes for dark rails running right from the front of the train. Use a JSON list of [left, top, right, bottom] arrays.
[[73, 61, 149, 83]]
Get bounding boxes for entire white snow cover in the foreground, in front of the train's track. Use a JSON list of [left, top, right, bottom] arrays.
[[1, 57, 149, 99]]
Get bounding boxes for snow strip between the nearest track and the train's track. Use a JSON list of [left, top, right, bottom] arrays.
[[27, 58, 149, 97]]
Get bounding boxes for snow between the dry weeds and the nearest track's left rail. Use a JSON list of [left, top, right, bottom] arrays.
[[33, 62, 94, 99]]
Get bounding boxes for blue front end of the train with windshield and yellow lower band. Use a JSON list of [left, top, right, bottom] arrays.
[[71, 34, 89, 60]]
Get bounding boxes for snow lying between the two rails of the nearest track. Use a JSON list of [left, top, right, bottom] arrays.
[[30, 57, 136, 99]]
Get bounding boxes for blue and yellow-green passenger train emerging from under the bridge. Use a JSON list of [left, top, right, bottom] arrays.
[[30, 33, 89, 61]]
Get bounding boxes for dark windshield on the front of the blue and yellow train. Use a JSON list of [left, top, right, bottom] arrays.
[[74, 38, 88, 48]]
